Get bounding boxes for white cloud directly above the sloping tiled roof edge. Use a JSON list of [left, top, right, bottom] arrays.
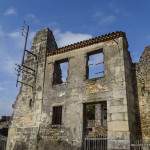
[[54, 29, 92, 47]]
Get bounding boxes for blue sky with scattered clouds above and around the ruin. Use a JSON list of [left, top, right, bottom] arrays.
[[0, 0, 150, 116]]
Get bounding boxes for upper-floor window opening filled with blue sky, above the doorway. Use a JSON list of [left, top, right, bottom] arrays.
[[87, 50, 104, 79]]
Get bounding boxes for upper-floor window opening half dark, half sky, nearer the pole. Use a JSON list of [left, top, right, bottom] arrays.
[[53, 59, 69, 84]]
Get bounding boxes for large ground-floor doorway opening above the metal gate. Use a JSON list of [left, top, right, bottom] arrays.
[[84, 102, 107, 136]]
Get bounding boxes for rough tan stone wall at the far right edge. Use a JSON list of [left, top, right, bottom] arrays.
[[136, 46, 150, 141]]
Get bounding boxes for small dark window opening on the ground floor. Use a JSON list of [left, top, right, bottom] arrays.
[[52, 106, 62, 125]]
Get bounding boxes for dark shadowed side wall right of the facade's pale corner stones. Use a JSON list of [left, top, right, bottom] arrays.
[[124, 43, 140, 143]]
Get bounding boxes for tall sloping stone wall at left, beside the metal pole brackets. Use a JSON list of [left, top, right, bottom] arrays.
[[7, 29, 57, 150]]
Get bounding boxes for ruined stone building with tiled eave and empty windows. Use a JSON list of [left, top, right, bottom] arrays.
[[7, 29, 150, 150]]
